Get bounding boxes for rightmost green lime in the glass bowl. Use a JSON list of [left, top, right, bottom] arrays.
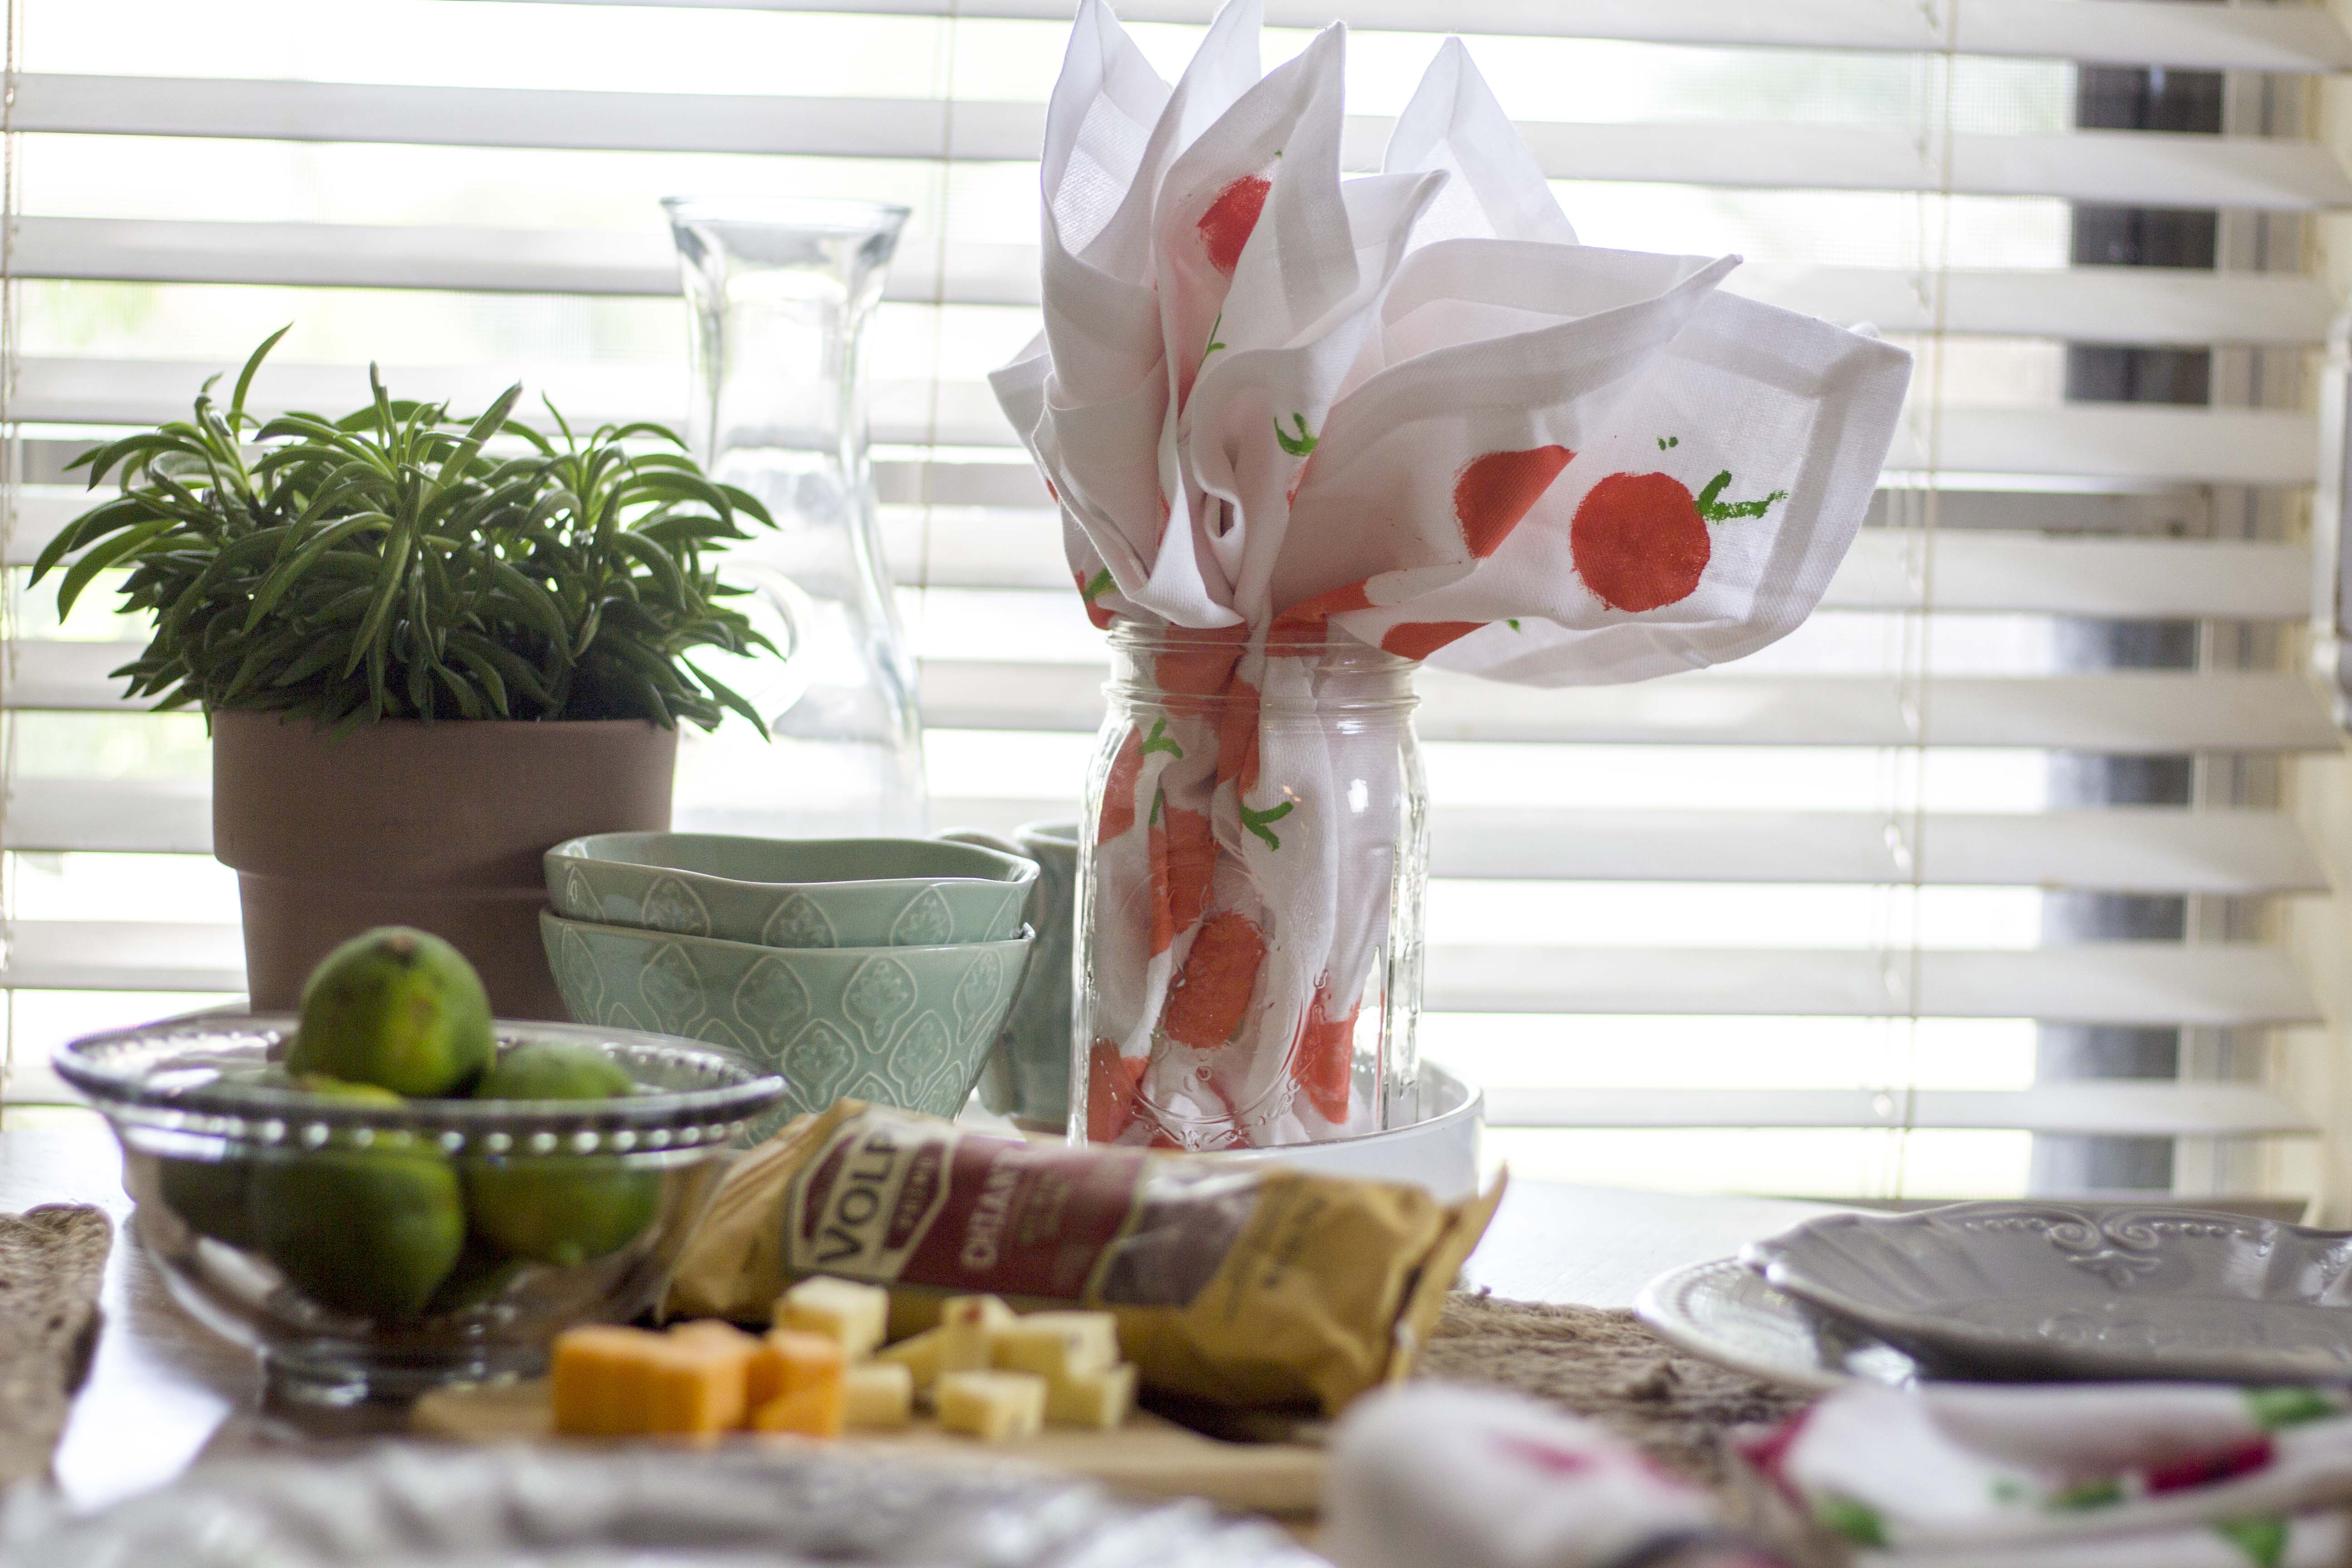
[[466, 1041, 661, 1267]]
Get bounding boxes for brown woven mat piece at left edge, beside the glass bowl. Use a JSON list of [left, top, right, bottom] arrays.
[[0, 1204, 115, 1483]]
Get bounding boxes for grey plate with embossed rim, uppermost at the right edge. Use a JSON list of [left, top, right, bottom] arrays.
[[1740, 1201, 2352, 1382]]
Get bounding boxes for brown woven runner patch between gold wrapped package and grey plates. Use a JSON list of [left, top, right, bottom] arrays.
[[1416, 1291, 1813, 1486]]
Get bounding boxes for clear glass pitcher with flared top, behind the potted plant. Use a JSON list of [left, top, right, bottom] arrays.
[[663, 197, 929, 837]]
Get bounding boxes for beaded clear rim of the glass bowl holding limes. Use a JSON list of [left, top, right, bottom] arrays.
[[49, 1013, 785, 1154]]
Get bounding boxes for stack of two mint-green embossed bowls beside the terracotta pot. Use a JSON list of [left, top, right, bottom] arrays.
[[541, 832, 1037, 1117]]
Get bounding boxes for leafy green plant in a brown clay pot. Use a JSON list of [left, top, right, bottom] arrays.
[[33, 332, 774, 1018]]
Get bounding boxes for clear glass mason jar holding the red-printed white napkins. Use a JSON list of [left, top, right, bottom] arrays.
[[1070, 621, 1430, 1150]]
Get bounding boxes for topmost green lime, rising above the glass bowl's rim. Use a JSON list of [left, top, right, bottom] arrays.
[[284, 926, 494, 1098]]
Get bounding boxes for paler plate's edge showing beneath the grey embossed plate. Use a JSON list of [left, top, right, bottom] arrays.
[[1632, 1258, 1919, 1394]]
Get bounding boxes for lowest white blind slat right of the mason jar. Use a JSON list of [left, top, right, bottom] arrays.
[[1486, 1081, 2319, 1138]]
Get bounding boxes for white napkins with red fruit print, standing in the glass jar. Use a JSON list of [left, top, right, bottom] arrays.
[[993, 0, 1910, 1145]]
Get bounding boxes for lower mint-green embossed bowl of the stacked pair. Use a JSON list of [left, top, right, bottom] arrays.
[[539, 915, 1030, 1124]]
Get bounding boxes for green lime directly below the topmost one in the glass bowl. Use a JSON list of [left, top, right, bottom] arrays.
[[252, 1077, 466, 1319]]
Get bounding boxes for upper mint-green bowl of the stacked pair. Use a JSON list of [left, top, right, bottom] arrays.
[[546, 832, 1037, 947]]
